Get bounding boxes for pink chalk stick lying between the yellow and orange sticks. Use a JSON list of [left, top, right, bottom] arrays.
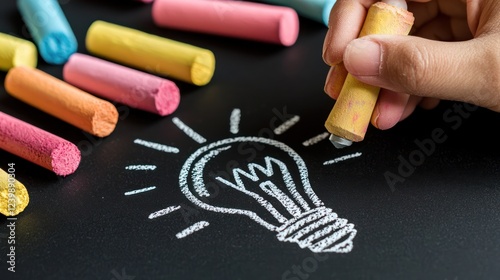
[[63, 53, 180, 116]]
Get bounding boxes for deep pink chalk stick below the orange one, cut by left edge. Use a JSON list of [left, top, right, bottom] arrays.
[[0, 112, 81, 176]]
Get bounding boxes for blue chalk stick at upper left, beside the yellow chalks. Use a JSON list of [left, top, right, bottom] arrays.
[[17, 0, 78, 65]]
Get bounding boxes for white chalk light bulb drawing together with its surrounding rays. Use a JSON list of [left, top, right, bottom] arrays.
[[123, 111, 362, 249]]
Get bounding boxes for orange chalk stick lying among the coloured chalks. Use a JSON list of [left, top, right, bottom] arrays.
[[5, 66, 118, 137]]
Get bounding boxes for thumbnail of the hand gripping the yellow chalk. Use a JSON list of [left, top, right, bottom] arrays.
[[344, 38, 382, 76]]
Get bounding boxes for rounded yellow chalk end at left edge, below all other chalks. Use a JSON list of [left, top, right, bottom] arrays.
[[0, 167, 30, 216]]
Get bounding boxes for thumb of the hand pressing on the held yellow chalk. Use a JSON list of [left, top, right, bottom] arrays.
[[344, 35, 500, 111]]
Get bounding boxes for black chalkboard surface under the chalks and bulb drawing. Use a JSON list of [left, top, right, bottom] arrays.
[[0, 0, 500, 280]]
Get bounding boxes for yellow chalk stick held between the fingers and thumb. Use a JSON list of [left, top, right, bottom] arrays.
[[325, 2, 414, 142]]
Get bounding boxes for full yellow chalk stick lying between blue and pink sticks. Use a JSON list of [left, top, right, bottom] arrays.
[[85, 20, 215, 86]]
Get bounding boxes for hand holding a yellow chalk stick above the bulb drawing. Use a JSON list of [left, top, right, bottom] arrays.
[[323, 0, 500, 129]]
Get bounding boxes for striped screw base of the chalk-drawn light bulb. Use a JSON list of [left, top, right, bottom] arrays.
[[277, 207, 357, 253]]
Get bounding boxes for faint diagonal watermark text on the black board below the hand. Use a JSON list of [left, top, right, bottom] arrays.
[[384, 103, 479, 192]]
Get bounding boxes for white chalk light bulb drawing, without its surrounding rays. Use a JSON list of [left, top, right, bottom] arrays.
[[179, 137, 357, 253]]
